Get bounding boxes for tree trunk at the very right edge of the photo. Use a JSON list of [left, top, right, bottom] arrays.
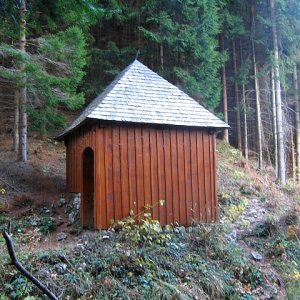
[[293, 64, 300, 181]]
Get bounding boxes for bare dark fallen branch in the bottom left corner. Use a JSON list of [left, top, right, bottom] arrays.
[[3, 224, 62, 300]]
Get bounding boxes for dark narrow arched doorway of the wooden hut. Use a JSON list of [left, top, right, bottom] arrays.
[[82, 147, 94, 228]]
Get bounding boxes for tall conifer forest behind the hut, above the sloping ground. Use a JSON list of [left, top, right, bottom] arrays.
[[0, 0, 300, 183]]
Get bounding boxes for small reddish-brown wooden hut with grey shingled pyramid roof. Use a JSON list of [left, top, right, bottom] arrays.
[[57, 60, 228, 228]]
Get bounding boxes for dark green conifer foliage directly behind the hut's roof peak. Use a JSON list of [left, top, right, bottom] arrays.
[[89, 0, 225, 110]]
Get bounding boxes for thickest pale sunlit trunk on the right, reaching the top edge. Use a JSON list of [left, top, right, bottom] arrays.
[[270, 0, 286, 184]]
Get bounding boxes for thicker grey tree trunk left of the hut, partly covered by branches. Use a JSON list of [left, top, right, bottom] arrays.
[[19, 0, 27, 161]]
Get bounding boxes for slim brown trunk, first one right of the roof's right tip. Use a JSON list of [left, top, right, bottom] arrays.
[[232, 39, 242, 152]]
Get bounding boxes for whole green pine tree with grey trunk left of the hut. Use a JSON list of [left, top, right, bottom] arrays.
[[0, 0, 101, 161]]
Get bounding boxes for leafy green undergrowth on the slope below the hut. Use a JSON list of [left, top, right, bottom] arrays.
[[0, 219, 263, 300]]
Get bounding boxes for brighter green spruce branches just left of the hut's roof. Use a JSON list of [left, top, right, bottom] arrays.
[[0, 27, 87, 133]]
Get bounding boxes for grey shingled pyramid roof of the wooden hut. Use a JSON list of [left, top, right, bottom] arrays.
[[57, 60, 229, 139]]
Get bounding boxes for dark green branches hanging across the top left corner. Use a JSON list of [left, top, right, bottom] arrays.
[[0, 0, 104, 39]]
